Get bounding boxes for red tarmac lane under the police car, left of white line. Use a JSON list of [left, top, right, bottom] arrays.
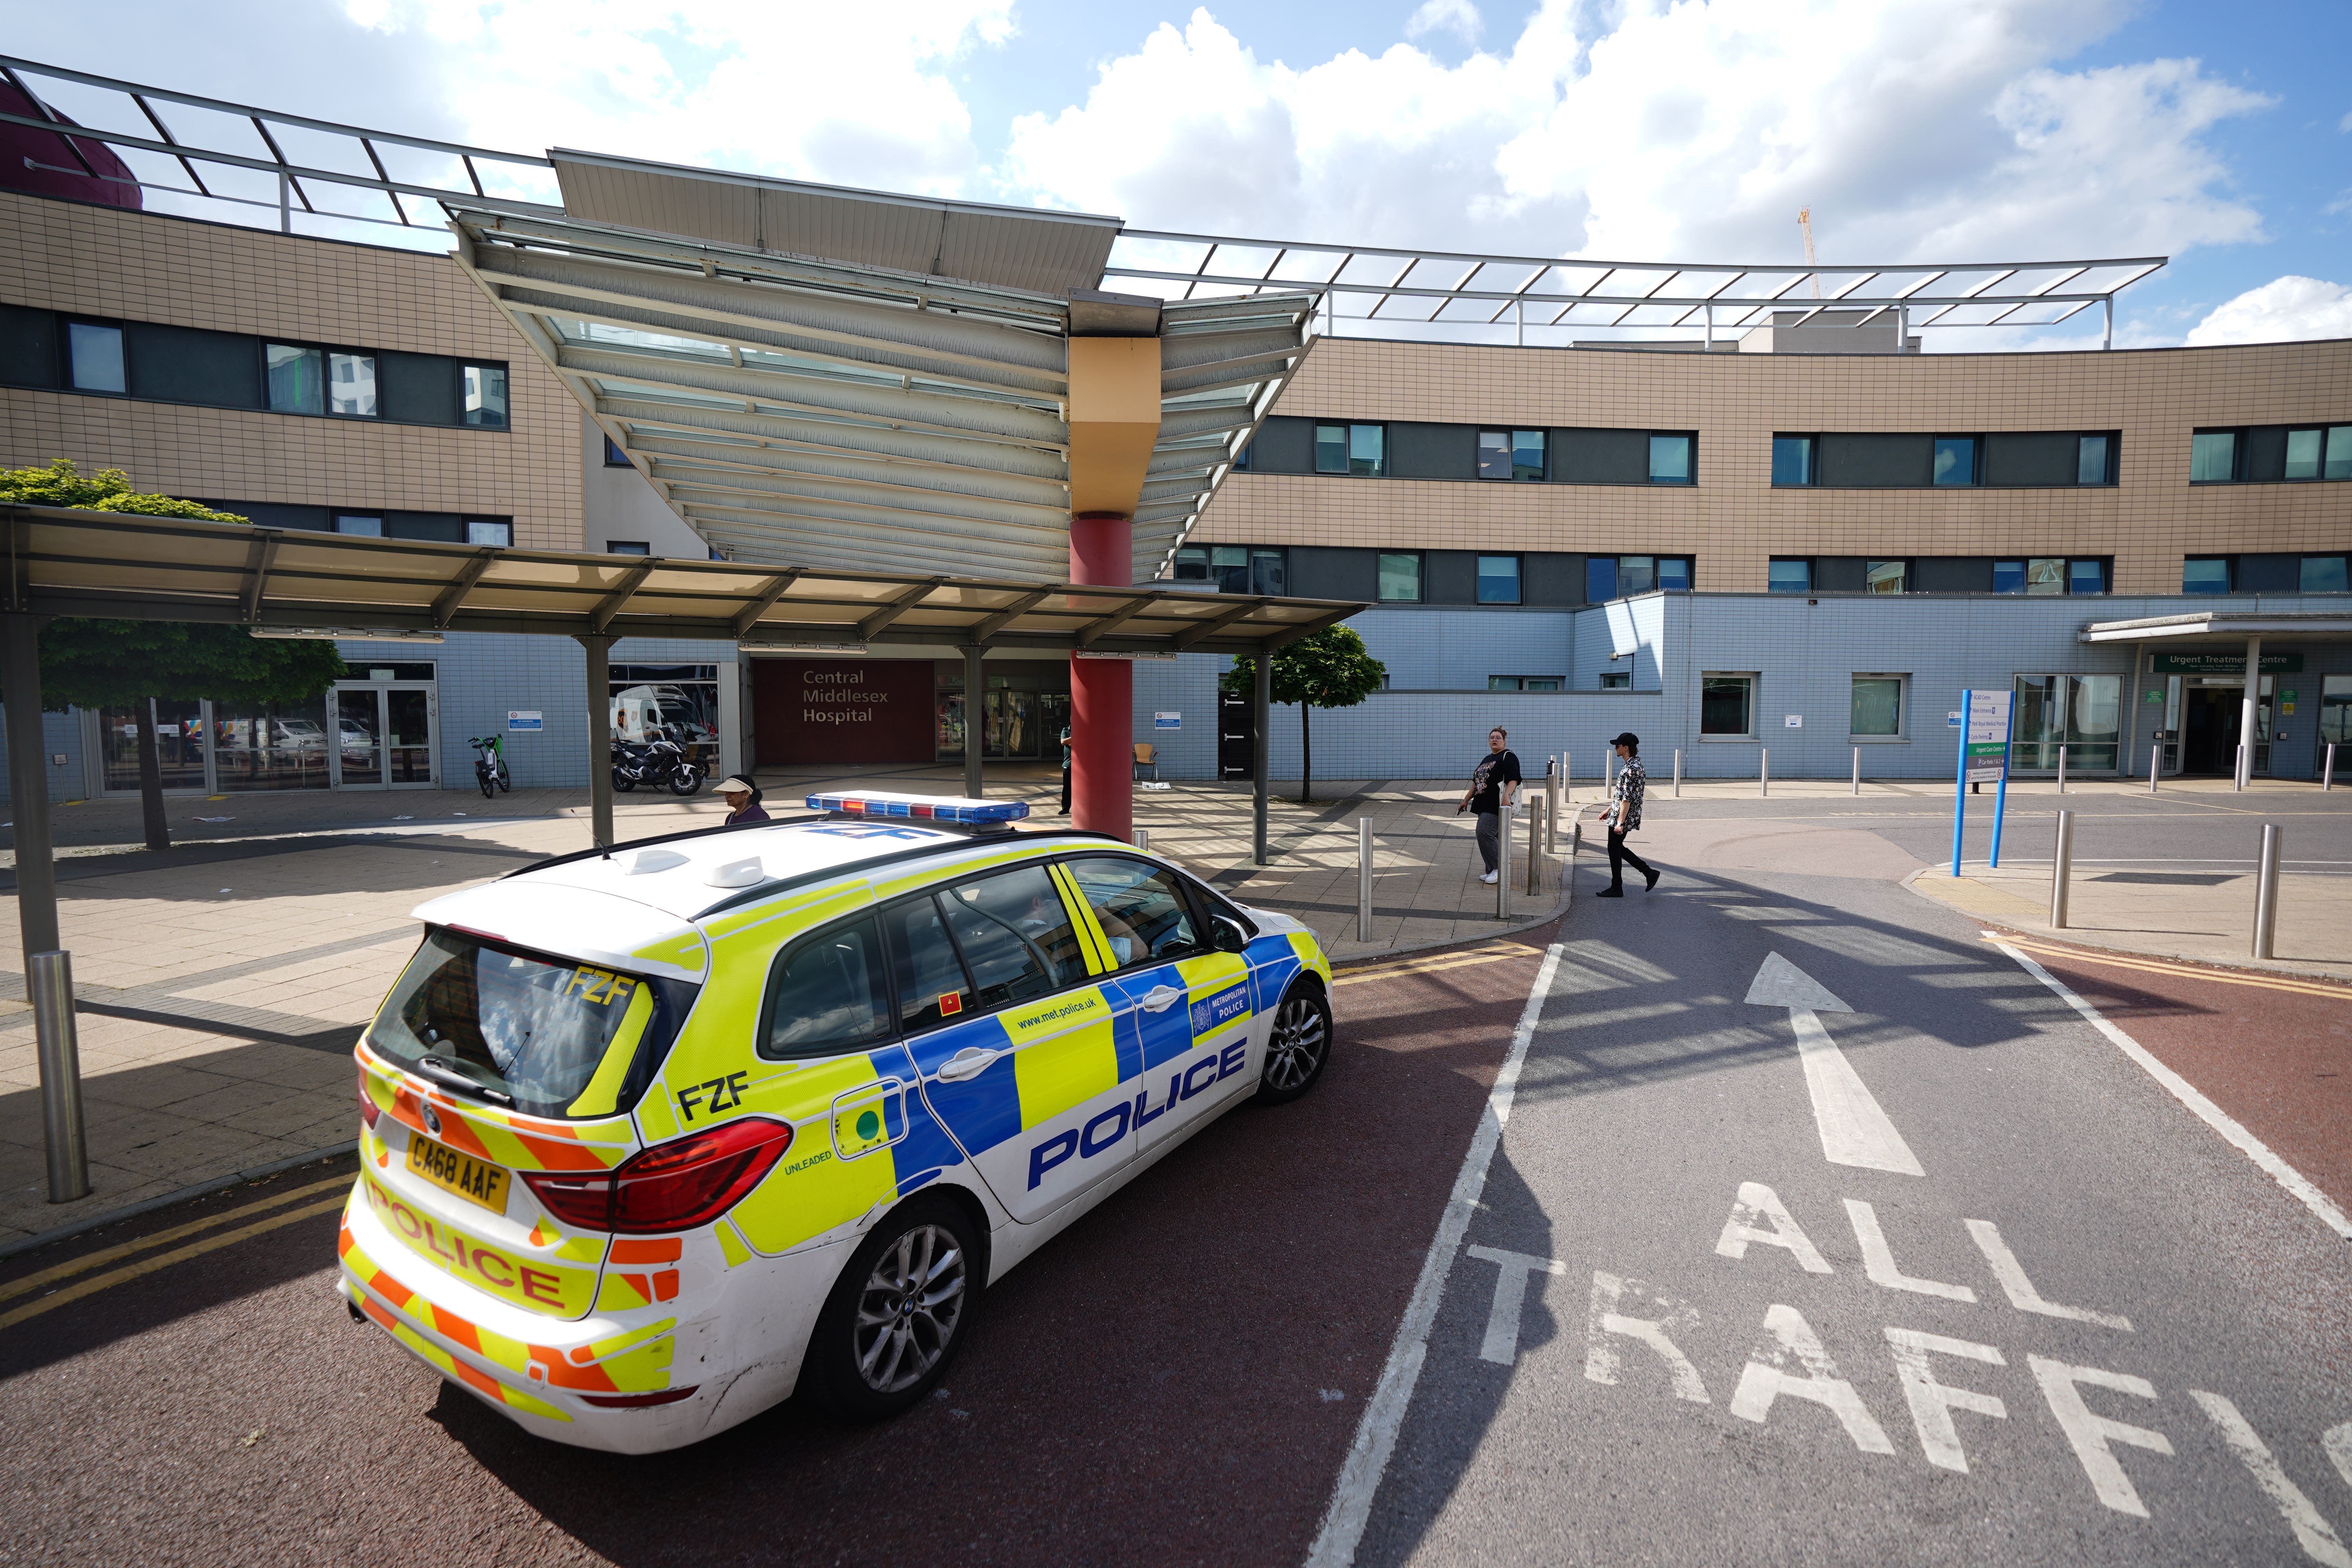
[[0, 929, 1552, 1568]]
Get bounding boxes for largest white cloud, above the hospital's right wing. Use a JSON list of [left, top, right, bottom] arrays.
[[1000, 0, 2270, 266]]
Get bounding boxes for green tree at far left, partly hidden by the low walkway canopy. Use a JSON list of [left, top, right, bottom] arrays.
[[0, 458, 343, 849]]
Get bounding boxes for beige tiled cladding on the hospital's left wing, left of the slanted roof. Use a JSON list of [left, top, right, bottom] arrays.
[[0, 193, 583, 550]]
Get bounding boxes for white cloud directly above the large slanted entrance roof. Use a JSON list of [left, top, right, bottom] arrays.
[[343, 0, 1014, 193]]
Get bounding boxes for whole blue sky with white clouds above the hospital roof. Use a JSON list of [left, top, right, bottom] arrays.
[[0, 0, 2352, 348]]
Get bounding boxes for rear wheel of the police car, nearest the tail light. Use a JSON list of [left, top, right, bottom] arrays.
[[802, 1196, 981, 1422]]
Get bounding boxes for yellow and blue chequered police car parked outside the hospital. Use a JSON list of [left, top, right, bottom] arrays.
[[336, 795, 1331, 1453]]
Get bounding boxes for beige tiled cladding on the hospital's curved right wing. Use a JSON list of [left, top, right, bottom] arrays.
[[1192, 339, 2352, 592]]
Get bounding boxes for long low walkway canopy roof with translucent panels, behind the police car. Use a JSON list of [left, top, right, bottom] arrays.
[[0, 505, 1364, 653]]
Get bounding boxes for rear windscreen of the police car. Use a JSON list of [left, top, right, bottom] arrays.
[[367, 929, 675, 1117]]
